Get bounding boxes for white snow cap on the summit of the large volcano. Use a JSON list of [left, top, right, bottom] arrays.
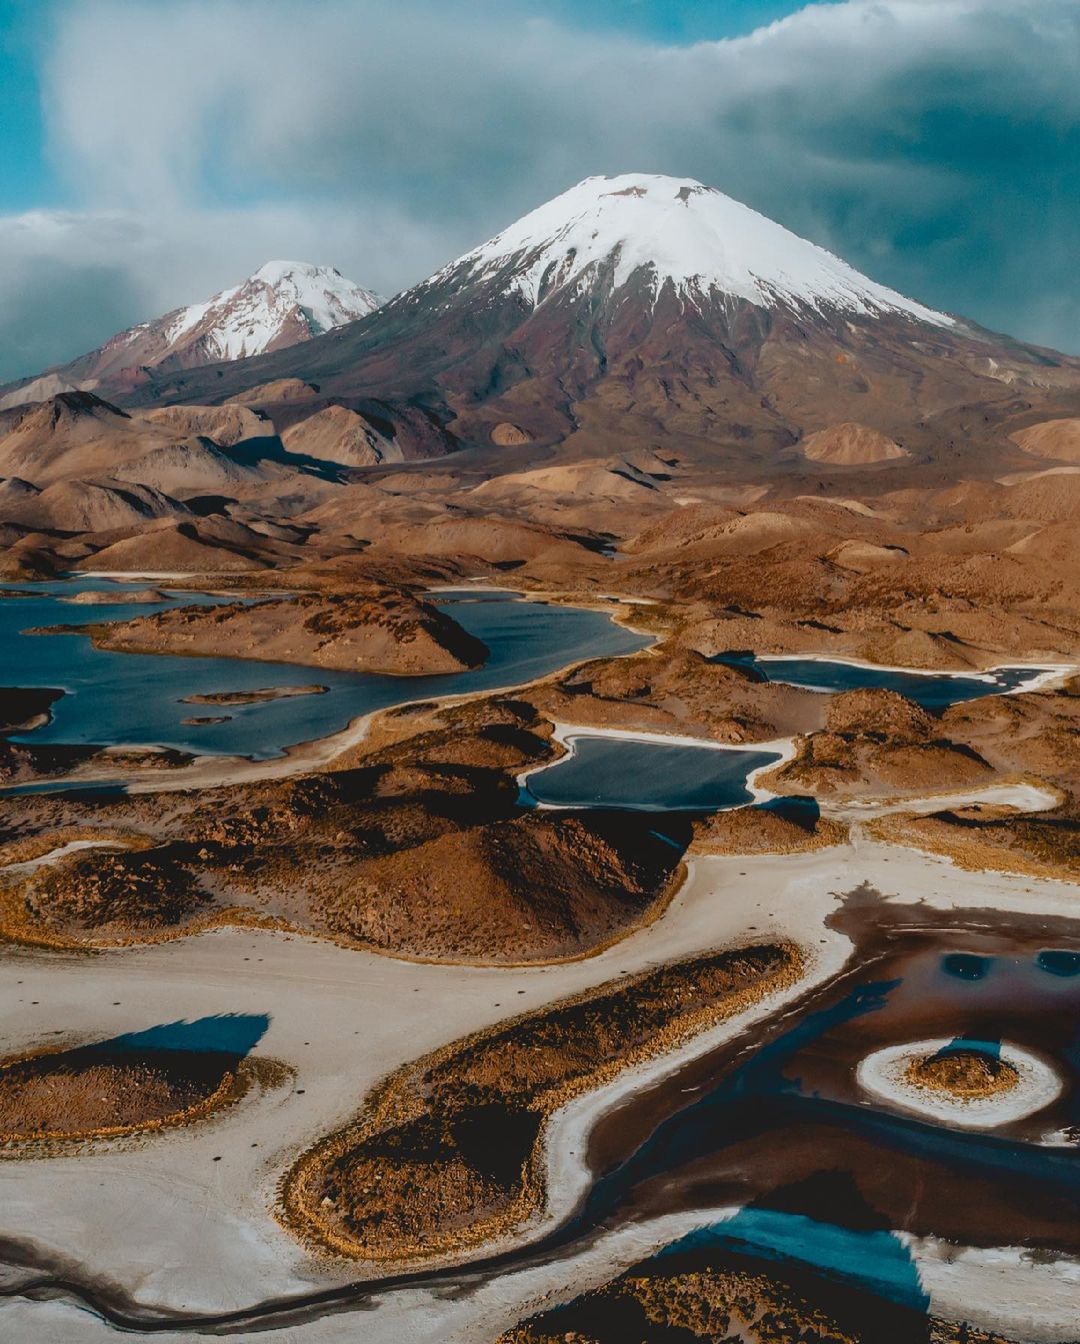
[[437, 173, 954, 327]]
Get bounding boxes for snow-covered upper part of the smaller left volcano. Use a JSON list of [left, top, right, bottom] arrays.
[[163, 261, 380, 360]]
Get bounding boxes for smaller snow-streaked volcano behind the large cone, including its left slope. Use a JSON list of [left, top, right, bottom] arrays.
[[0, 261, 380, 407]]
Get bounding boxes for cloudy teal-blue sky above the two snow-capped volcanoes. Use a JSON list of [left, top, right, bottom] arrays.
[[0, 0, 1080, 380]]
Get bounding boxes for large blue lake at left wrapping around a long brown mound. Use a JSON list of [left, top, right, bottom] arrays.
[[0, 581, 650, 759]]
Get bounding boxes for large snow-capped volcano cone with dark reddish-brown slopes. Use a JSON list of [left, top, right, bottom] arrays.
[[71, 173, 1075, 461]]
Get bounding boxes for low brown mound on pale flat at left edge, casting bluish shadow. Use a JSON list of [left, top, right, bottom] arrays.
[[0, 1043, 236, 1141]]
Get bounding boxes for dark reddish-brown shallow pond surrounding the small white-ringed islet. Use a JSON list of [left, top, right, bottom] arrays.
[[578, 911, 1080, 1274]]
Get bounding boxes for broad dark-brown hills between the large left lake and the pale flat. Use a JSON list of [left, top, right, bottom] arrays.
[[0, 700, 680, 964]]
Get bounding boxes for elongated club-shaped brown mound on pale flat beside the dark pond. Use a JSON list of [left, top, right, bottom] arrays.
[[282, 945, 801, 1261]]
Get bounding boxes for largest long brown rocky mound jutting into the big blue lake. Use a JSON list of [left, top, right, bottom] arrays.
[[94, 589, 488, 676]]
